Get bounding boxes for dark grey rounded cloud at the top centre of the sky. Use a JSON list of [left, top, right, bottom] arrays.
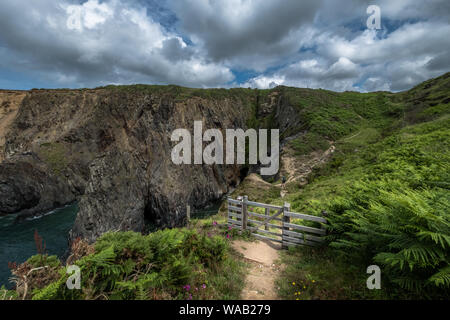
[[170, 0, 321, 71]]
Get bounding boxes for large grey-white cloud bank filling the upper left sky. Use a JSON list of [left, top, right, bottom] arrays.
[[0, 0, 234, 87]]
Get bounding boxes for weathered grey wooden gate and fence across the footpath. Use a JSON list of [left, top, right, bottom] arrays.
[[228, 196, 327, 248]]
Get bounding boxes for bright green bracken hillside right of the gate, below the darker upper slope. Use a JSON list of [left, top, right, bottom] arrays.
[[280, 115, 450, 298]]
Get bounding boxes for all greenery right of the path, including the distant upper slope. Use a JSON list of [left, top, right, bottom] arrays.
[[95, 74, 450, 299]]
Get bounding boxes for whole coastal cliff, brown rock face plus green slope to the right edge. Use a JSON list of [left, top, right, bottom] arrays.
[[0, 73, 450, 242]]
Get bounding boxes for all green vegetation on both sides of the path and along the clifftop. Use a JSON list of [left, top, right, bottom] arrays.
[[4, 73, 450, 299]]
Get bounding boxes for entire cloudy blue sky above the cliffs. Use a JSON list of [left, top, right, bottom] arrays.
[[0, 0, 450, 92]]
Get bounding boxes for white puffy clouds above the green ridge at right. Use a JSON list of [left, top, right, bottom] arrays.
[[247, 21, 450, 91]]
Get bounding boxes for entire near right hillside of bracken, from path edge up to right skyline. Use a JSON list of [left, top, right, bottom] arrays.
[[274, 75, 450, 299]]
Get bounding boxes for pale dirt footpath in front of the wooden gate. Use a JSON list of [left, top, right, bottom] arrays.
[[233, 240, 281, 300]]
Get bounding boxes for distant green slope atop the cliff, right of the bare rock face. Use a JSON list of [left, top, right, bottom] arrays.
[[281, 87, 402, 141]]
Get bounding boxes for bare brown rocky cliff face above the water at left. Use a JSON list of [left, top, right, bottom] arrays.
[[0, 87, 256, 241]]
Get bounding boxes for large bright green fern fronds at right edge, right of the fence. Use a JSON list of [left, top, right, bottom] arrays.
[[331, 185, 450, 293]]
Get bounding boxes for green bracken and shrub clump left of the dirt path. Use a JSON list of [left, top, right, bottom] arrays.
[[27, 229, 240, 299]]
